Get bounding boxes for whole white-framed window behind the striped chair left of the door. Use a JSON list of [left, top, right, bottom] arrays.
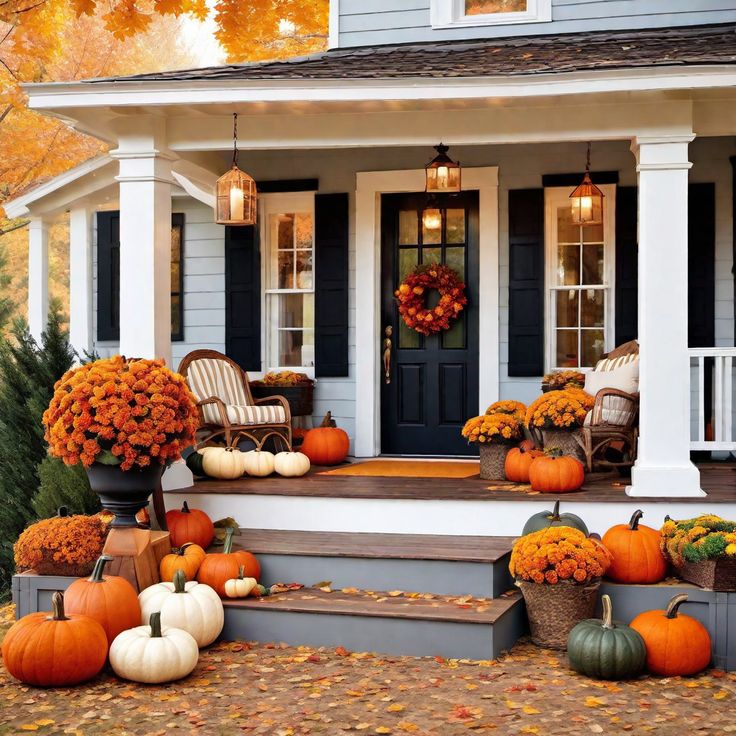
[[261, 194, 314, 370]]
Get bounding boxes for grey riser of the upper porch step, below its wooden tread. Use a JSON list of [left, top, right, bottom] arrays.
[[257, 554, 512, 598]]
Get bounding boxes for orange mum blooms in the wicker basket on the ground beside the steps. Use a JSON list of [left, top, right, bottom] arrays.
[[509, 526, 611, 585]]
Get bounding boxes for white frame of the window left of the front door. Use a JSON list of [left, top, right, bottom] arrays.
[[258, 192, 316, 378]]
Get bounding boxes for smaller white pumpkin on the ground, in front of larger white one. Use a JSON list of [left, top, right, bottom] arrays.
[[110, 611, 199, 684]]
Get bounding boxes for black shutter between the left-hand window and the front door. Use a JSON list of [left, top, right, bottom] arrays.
[[314, 194, 349, 377]]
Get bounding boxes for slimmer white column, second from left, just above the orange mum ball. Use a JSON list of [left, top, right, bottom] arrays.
[[69, 207, 92, 358]]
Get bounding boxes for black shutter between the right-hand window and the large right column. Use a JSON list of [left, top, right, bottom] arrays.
[[616, 187, 639, 345]]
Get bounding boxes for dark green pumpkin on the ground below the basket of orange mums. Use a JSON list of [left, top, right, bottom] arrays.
[[567, 595, 647, 680]]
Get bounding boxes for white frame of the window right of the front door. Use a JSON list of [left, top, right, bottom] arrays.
[[544, 184, 616, 373]]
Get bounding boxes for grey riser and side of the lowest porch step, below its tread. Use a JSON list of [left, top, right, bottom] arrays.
[[223, 604, 526, 659]]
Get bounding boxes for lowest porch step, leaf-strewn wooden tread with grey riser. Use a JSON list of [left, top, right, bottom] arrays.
[[223, 588, 526, 659]]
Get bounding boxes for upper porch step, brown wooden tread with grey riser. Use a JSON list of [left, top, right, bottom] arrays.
[[234, 529, 513, 598]]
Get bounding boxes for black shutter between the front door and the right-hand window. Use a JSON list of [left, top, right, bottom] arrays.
[[509, 189, 544, 376]]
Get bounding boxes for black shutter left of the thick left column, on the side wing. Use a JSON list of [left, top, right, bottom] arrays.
[[97, 211, 120, 341]]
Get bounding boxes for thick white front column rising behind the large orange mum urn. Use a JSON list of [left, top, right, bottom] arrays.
[[112, 120, 174, 365]]
